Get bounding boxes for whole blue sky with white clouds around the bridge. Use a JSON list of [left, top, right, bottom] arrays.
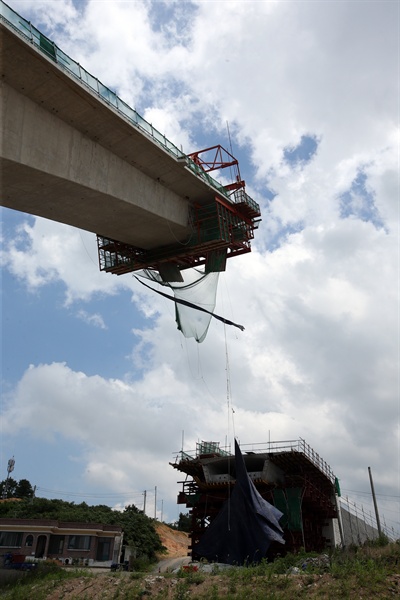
[[1, 0, 400, 531]]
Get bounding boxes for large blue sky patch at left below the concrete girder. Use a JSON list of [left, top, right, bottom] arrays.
[[2, 248, 151, 384]]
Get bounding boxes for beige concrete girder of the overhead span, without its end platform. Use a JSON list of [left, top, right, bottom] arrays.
[[0, 3, 225, 248]]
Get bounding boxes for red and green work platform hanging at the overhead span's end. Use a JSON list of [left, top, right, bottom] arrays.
[[97, 145, 261, 278]]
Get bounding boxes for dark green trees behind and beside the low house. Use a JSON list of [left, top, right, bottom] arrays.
[[0, 490, 164, 561]]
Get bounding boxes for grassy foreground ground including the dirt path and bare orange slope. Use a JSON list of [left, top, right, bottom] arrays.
[[0, 525, 400, 600]]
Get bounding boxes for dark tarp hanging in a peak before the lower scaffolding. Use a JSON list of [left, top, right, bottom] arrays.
[[194, 440, 285, 565]]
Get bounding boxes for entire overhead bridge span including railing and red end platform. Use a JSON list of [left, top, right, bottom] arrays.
[[0, 0, 260, 273]]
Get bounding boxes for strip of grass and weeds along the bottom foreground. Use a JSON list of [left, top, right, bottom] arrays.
[[0, 543, 400, 600]]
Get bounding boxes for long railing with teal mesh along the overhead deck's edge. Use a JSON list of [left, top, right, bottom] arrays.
[[0, 0, 230, 200]]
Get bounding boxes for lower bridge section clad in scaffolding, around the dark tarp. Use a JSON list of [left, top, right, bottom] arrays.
[[170, 438, 338, 558]]
